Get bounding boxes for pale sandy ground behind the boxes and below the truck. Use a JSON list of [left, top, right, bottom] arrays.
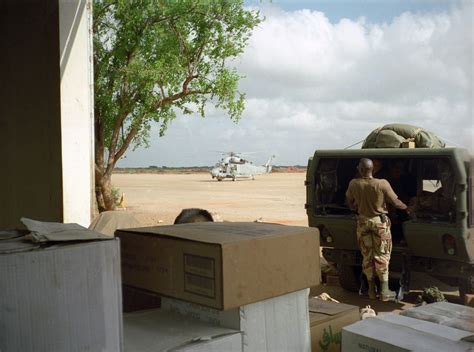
[[112, 173, 460, 312]]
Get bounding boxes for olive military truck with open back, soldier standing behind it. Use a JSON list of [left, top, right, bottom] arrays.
[[305, 148, 474, 299]]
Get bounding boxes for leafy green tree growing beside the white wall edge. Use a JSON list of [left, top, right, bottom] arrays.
[[93, 0, 261, 211]]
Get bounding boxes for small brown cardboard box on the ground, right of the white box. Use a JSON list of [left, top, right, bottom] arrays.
[[309, 298, 360, 352]]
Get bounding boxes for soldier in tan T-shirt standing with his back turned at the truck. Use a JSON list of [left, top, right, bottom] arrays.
[[346, 158, 407, 301]]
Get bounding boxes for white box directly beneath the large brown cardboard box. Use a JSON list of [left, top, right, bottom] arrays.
[[162, 289, 311, 352]]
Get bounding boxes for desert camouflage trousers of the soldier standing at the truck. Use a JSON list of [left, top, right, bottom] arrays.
[[357, 216, 392, 281]]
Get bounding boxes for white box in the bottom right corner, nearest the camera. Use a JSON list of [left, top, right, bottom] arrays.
[[342, 314, 473, 352]]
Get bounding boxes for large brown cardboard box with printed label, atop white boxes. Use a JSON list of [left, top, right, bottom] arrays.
[[116, 222, 320, 309]]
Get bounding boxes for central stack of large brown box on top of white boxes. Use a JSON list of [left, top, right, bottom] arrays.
[[116, 223, 320, 351]]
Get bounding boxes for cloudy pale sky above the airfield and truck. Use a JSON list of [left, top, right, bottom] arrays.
[[118, 0, 474, 167]]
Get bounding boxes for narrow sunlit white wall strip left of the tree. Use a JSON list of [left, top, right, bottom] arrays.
[[59, 0, 94, 226]]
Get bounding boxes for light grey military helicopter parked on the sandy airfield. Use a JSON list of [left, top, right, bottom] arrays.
[[211, 152, 275, 181]]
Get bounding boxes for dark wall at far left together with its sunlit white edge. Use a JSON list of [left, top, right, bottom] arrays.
[[0, 0, 92, 229]]
